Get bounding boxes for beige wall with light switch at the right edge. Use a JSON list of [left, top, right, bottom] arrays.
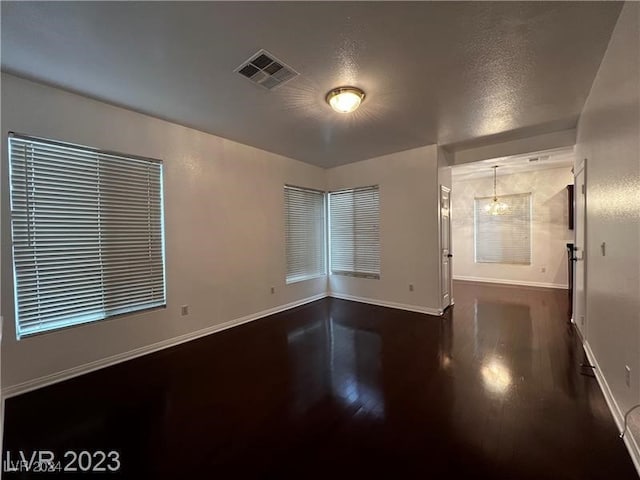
[[576, 2, 640, 462]]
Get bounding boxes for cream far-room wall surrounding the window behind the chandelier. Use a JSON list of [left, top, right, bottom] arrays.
[[452, 167, 573, 288]]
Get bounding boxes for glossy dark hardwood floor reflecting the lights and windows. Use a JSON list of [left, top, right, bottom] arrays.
[[3, 282, 637, 480]]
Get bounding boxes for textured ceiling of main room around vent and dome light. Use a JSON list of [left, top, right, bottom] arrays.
[[1, 2, 621, 167]]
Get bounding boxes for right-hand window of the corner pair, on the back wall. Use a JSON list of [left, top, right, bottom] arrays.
[[329, 186, 380, 278]]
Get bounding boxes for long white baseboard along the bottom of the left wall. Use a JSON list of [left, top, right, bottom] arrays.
[[0, 293, 328, 402]]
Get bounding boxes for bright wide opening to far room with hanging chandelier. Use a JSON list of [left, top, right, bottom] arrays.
[[451, 147, 575, 290]]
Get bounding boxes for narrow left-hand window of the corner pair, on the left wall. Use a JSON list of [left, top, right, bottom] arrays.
[[284, 185, 326, 283]]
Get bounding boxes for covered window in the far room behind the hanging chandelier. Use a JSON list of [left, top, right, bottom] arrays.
[[475, 193, 531, 265]]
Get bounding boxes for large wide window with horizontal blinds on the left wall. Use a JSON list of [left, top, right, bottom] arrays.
[[9, 134, 166, 338]]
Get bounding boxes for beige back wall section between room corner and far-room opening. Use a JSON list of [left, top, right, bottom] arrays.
[[327, 145, 440, 313]]
